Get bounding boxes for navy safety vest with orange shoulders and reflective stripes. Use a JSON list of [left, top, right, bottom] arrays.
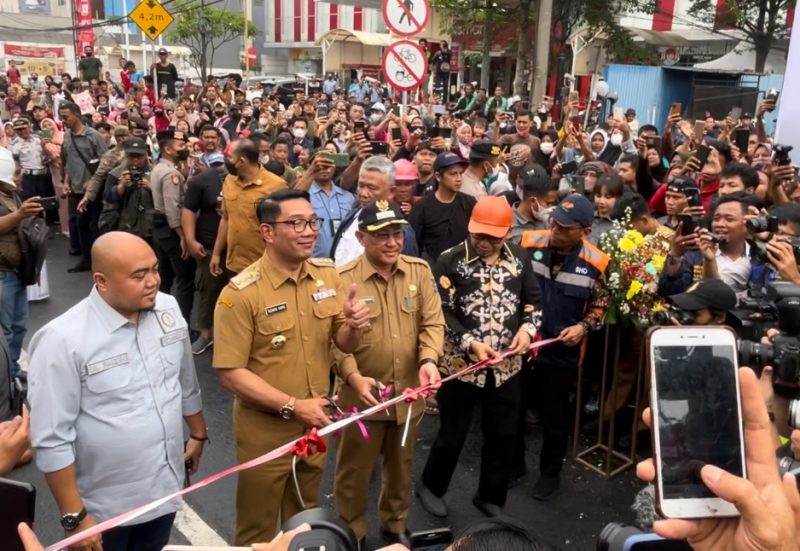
[[521, 230, 608, 367]]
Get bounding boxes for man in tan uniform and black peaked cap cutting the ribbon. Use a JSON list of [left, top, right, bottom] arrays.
[[335, 200, 444, 549]]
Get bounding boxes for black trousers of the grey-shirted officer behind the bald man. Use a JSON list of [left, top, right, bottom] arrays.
[[153, 228, 196, 324]]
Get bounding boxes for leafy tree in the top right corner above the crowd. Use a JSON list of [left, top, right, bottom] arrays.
[[689, 0, 795, 73]]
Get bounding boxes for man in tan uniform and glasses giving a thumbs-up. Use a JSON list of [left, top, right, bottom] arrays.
[[213, 189, 370, 545]]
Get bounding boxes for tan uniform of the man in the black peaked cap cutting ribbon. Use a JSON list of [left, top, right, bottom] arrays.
[[335, 255, 445, 539]]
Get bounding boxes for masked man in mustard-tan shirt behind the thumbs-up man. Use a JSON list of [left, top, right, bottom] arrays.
[[209, 140, 286, 276]]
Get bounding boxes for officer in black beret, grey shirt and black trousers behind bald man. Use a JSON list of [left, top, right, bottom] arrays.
[[150, 130, 195, 321]]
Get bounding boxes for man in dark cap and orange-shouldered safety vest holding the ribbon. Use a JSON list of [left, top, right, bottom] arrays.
[[522, 194, 608, 501]]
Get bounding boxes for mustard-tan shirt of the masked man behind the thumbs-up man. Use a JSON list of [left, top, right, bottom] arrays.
[[222, 167, 287, 273]]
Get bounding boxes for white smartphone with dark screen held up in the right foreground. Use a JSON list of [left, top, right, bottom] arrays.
[[648, 326, 747, 519]]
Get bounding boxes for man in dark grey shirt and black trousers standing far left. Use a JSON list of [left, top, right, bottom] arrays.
[[58, 102, 107, 273]]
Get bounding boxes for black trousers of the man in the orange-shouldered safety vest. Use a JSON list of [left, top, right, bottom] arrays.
[[534, 362, 578, 475]]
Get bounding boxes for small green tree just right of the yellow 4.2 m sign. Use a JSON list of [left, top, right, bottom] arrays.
[[169, 0, 257, 82]]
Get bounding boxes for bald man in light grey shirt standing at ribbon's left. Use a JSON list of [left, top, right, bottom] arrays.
[[28, 232, 208, 550]]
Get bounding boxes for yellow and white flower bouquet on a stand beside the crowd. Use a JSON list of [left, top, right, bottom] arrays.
[[599, 220, 669, 328]]
